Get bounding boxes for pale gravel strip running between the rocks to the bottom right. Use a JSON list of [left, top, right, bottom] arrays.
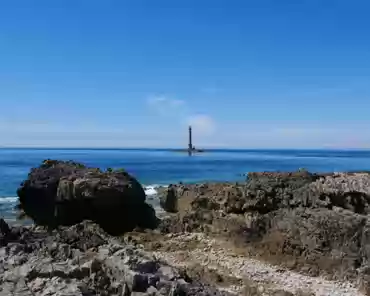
[[146, 232, 364, 296]]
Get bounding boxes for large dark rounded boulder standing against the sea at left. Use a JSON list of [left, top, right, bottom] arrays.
[[17, 160, 157, 233]]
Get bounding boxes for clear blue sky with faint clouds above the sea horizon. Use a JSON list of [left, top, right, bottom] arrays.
[[0, 0, 370, 148]]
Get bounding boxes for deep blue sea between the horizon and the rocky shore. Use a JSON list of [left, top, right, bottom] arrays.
[[0, 149, 370, 220]]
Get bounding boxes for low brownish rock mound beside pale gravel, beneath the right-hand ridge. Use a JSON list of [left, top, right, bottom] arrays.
[[240, 207, 370, 279]]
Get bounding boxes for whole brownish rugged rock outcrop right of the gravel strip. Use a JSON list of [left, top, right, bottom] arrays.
[[160, 171, 370, 282]]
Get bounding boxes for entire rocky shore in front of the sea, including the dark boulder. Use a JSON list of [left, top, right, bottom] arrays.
[[0, 160, 370, 296]]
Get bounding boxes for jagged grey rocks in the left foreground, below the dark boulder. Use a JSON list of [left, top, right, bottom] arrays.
[[0, 221, 228, 296]]
